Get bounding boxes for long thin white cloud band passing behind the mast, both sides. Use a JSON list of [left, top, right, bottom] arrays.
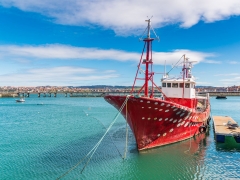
[[0, 44, 214, 65]]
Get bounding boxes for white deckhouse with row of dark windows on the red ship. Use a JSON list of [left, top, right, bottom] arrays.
[[162, 78, 195, 99]]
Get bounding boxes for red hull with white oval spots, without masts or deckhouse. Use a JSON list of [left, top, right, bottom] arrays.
[[104, 95, 210, 150]]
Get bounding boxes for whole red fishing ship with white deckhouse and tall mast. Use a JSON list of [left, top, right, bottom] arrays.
[[104, 19, 210, 150]]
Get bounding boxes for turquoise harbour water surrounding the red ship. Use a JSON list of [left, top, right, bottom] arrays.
[[0, 95, 240, 180]]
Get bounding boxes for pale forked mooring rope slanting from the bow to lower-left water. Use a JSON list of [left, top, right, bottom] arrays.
[[57, 95, 130, 180]]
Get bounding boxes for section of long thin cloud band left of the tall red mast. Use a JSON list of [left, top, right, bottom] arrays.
[[0, 44, 139, 61]]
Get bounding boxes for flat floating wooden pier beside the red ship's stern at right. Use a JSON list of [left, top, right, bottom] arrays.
[[213, 116, 240, 143]]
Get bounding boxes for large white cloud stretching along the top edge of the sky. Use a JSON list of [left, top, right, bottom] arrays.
[[0, 0, 240, 34]]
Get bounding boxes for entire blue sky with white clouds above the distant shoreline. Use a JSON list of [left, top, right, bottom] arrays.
[[0, 0, 240, 87]]
